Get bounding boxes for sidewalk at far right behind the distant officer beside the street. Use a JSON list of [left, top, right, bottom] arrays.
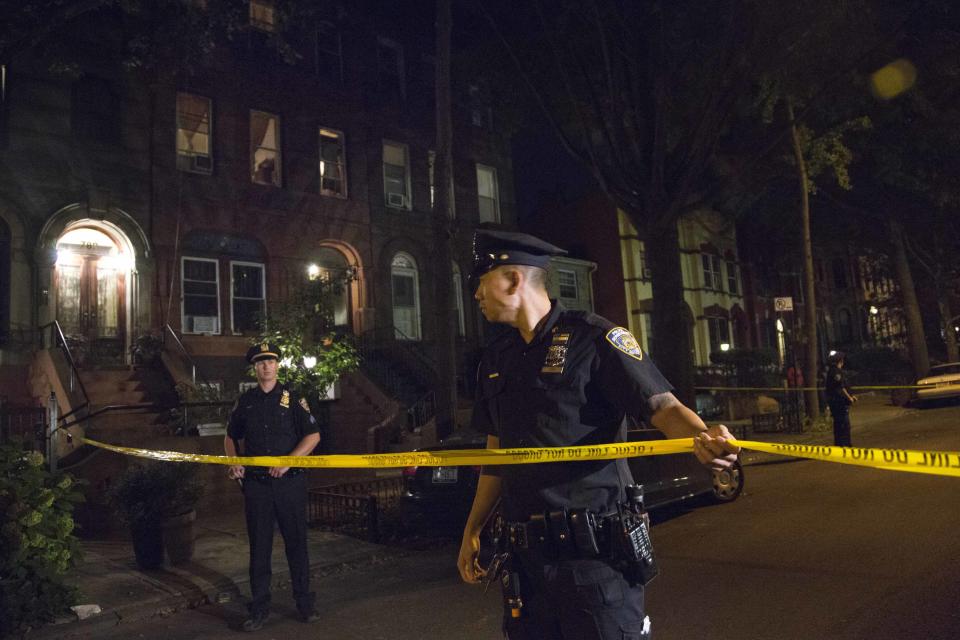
[[728, 392, 916, 466]]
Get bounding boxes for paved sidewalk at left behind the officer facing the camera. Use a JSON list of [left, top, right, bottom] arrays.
[[27, 507, 402, 639]]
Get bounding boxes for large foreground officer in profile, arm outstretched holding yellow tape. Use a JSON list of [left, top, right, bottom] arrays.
[[458, 230, 739, 640]]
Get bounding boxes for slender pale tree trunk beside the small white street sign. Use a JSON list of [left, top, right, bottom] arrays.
[[787, 100, 820, 420]]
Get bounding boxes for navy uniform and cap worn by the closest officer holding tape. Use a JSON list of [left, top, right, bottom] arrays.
[[472, 232, 672, 640]]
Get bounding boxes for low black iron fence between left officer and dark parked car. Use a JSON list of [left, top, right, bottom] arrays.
[[307, 477, 403, 542]]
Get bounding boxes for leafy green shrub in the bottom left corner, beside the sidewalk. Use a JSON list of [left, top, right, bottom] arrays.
[[0, 442, 83, 636]]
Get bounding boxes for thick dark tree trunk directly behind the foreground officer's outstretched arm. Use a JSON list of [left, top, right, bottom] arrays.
[[630, 214, 695, 407]]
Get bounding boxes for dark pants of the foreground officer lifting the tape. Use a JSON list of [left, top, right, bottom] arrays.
[[503, 552, 647, 640]]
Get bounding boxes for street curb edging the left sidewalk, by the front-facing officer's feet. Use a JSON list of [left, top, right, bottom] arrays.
[[20, 547, 407, 640]]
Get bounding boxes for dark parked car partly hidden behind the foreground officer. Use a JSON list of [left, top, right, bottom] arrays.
[[400, 428, 743, 531]]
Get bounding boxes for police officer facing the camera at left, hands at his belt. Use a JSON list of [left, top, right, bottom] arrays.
[[223, 343, 320, 631]]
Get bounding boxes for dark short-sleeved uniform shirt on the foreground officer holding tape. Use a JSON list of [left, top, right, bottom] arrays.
[[472, 302, 672, 520]]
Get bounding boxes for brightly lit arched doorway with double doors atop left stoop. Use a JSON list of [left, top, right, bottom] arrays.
[[53, 220, 135, 364]]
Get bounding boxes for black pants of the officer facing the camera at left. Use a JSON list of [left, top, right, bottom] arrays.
[[243, 474, 314, 613]]
